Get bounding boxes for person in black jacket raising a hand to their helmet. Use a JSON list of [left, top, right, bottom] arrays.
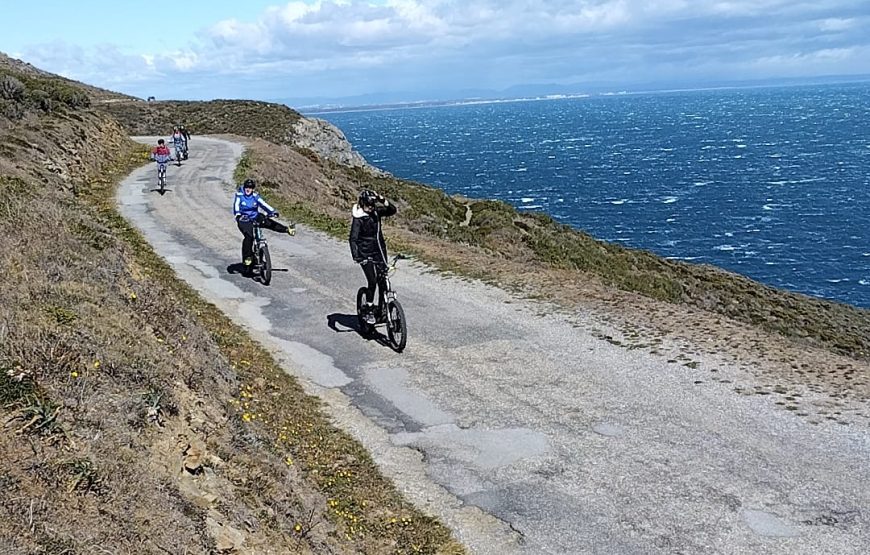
[[350, 189, 396, 324]]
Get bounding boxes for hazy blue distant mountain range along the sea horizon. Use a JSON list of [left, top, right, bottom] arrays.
[[280, 75, 870, 113]]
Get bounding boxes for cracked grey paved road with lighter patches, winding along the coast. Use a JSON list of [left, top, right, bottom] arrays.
[[118, 137, 870, 555]]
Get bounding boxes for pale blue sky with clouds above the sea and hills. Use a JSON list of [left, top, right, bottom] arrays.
[[0, 0, 870, 102]]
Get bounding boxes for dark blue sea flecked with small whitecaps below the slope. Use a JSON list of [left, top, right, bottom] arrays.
[[318, 83, 870, 307]]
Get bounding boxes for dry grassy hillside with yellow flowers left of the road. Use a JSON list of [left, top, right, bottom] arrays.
[[0, 54, 461, 554]]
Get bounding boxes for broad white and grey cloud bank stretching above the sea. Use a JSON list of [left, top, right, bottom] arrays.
[[11, 0, 870, 97]]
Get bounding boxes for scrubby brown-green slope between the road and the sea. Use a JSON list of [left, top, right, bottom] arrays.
[[240, 141, 870, 359]]
